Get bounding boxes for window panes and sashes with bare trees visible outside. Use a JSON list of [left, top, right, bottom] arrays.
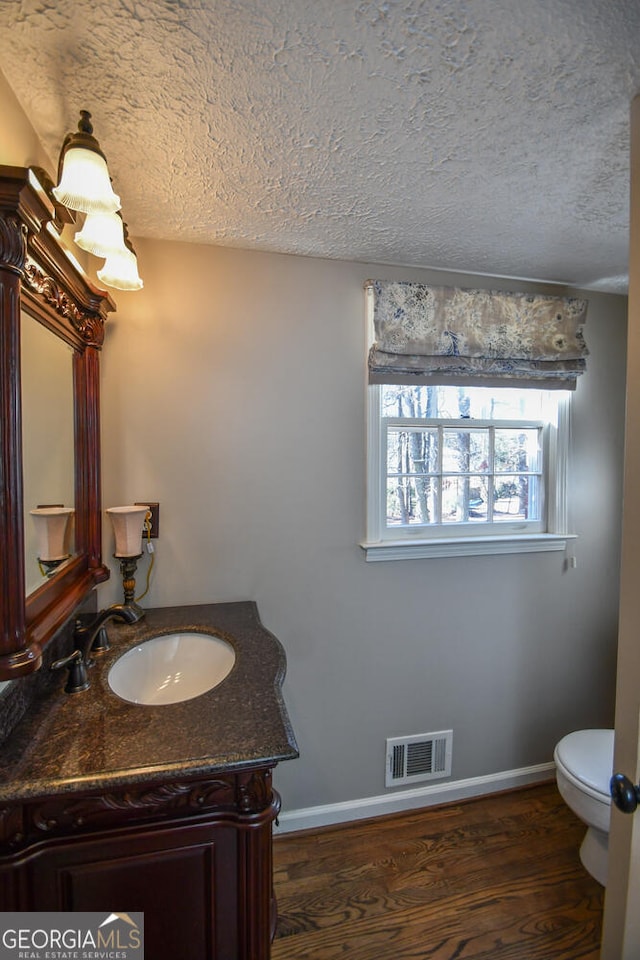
[[382, 385, 544, 527]]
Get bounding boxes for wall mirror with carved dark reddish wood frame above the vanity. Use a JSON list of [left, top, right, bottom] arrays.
[[0, 166, 115, 680]]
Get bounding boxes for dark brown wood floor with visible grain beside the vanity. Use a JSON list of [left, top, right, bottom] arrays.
[[272, 784, 603, 960]]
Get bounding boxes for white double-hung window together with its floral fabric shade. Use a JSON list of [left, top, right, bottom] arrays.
[[362, 280, 588, 560]]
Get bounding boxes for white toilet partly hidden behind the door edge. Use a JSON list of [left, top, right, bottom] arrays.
[[553, 730, 614, 886]]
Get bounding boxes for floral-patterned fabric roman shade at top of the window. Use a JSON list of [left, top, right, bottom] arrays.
[[365, 280, 589, 390]]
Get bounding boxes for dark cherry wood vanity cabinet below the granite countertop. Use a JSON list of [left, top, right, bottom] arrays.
[[0, 768, 280, 960]]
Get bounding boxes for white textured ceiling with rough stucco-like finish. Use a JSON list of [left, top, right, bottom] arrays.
[[0, 0, 640, 292]]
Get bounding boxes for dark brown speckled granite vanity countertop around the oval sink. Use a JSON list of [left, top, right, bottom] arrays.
[[0, 601, 298, 803]]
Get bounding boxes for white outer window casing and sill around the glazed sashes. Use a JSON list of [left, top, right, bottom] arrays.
[[360, 384, 576, 561]]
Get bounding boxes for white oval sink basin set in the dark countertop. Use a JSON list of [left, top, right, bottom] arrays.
[[108, 633, 236, 705]]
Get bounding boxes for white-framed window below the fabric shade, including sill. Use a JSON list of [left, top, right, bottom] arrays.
[[362, 384, 570, 560]]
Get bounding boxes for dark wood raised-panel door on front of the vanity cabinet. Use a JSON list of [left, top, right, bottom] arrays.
[[29, 824, 238, 960]]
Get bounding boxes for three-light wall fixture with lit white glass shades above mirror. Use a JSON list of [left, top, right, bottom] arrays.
[[52, 110, 143, 290]]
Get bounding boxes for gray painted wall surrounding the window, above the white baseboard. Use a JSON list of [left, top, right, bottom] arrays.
[[100, 241, 626, 809]]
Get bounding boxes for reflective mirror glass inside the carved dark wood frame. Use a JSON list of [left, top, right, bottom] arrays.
[[21, 312, 74, 596]]
